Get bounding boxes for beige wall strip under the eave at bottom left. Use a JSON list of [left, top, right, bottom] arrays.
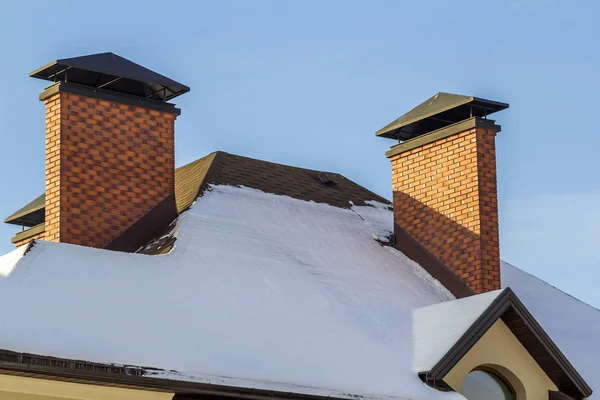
[[0, 374, 173, 400]]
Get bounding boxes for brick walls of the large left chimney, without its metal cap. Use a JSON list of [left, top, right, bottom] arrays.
[[44, 93, 176, 247]]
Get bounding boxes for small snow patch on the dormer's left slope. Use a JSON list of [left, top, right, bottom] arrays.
[[413, 290, 502, 373]]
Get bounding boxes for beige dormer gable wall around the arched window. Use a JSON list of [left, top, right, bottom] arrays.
[[444, 320, 558, 400]]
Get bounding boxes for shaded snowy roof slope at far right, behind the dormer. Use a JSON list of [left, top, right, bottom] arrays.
[[500, 262, 600, 399]]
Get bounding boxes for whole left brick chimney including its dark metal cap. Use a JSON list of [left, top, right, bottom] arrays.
[[30, 53, 189, 248]]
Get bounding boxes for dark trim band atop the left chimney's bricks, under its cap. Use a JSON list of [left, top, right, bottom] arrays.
[[40, 82, 181, 115]]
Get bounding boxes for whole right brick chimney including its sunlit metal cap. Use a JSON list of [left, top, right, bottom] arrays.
[[377, 93, 508, 293]]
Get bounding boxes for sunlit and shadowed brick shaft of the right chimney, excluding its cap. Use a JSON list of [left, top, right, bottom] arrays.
[[390, 128, 500, 293]]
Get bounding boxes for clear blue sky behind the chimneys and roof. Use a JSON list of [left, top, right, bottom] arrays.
[[0, 0, 600, 307]]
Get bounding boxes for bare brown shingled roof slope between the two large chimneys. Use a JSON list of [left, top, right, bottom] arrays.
[[143, 151, 390, 255]]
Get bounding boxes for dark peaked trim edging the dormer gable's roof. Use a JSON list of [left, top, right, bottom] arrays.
[[421, 288, 592, 399]]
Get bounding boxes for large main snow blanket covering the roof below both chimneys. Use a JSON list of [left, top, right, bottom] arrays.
[[0, 186, 460, 399]]
